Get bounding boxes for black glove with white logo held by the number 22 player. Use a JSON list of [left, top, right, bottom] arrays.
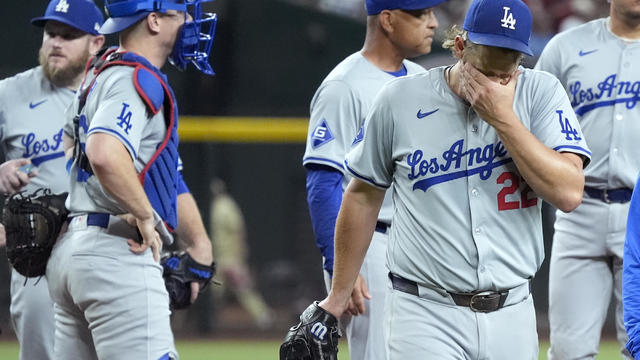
[[280, 301, 340, 360]]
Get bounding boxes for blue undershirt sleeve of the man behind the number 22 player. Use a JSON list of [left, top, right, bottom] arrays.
[[306, 164, 343, 277]]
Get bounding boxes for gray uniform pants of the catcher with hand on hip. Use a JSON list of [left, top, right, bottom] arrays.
[[47, 225, 178, 360]]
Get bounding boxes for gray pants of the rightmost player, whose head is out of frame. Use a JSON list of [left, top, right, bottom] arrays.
[[549, 198, 631, 360]]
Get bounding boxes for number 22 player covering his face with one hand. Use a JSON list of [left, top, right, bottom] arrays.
[[314, 0, 591, 360]]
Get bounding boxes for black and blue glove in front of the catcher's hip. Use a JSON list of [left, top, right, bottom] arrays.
[[160, 251, 216, 310]]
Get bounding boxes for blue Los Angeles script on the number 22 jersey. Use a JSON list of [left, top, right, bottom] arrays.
[[407, 139, 513, 191]]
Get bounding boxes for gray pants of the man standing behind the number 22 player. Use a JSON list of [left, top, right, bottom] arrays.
[[324, 231, 389, 360]]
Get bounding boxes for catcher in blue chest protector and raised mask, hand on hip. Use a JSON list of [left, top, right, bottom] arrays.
[[47, 0, 216, 360]]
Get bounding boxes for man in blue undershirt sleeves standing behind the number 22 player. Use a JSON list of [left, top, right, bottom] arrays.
[[302, 0, 444, 359]]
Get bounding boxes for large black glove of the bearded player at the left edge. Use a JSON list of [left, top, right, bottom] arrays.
[[2, 189, 69, 277]]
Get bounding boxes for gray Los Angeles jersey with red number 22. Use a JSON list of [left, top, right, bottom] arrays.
[[345, 67, 591, 292]]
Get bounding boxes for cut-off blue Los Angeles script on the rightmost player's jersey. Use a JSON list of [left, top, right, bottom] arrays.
[[569, 74, 640, 116]]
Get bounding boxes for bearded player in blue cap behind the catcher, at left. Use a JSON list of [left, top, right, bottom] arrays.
[[0, 0, 104, 360]]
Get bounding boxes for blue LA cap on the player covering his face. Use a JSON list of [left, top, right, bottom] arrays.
[[462, 0, 533, 56]]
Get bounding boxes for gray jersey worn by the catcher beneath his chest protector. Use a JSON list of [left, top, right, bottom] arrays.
[[64, 66, 166, 216]]
